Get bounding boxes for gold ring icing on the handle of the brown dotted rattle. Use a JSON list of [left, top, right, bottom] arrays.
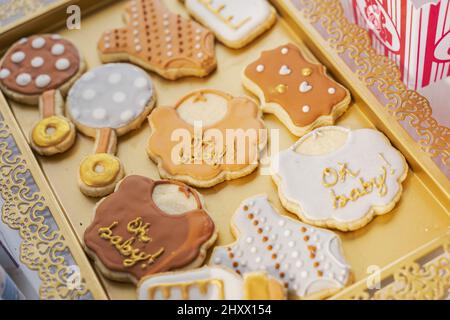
[[31, 116, 70, 148]]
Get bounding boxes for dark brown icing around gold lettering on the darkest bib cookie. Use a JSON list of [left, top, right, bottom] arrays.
[[84, 176, 215, 279]]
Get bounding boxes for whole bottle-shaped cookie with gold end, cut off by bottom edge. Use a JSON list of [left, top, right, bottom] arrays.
[[138, 266, 286, 300]]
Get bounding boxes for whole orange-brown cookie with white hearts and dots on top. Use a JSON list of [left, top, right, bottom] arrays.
[[243, 44, 350, 136]]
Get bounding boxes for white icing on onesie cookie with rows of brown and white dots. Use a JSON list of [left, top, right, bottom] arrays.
[[211, 196, 350, 297]]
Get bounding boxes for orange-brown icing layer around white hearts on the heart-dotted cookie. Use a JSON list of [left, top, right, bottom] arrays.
[[245, 44, 347, 127]]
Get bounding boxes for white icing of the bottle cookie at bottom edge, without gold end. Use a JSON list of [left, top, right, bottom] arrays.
[[138, 267, 244, 300]]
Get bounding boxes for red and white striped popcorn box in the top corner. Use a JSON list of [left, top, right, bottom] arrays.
[[341, 0, 450, 91]]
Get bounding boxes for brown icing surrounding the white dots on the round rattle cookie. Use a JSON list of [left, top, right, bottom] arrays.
[[0, 35, 80, 95]]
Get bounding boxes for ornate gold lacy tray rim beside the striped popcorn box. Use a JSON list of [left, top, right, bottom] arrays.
[[279, 0, 450, 179]]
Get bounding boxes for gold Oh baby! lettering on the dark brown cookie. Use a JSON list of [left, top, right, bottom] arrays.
[[98, 218, 164, 268]]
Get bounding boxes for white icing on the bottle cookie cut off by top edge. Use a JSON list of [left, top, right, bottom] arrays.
[[185, 0, 273, 42]]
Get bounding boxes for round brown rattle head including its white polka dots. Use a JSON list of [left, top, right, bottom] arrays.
[[0, 35, 81, 95]]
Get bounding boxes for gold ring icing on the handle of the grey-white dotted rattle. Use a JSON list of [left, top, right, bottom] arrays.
[[80, 153, 120, 187]]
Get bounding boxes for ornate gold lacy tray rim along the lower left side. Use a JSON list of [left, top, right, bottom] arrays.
[[0, 115, 90, 299]]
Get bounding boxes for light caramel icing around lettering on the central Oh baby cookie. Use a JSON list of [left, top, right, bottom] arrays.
[[148, 90, 264, 180]]
